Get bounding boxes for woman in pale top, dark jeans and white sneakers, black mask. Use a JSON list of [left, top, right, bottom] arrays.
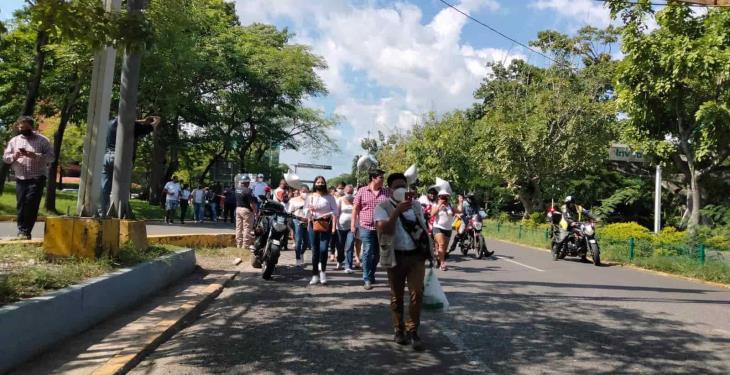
[[304, 176, 337, 285]]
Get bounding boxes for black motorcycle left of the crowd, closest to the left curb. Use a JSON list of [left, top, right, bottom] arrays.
[[251, 200, 289, 280]]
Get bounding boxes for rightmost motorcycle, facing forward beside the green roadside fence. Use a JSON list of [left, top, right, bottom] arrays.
[[548, 209, 601, 266]]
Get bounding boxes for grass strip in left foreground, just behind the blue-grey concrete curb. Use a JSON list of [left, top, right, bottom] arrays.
[[0, 244, 178, 305]]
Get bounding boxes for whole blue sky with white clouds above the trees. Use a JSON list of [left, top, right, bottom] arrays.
[[0, 0, 611, 179]]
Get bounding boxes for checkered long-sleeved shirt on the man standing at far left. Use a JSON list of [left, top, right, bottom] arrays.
[[3, 132, 53, 180]]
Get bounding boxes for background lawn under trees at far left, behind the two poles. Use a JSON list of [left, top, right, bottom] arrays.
[[0, 182, 165, 220]]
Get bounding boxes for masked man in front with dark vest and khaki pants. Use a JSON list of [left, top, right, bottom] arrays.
[[374, 173, 431, 351]]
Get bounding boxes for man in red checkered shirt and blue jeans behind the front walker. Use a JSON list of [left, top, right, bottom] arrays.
[[350, 169, 390, 290]]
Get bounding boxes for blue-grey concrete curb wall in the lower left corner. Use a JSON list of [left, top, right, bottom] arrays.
[[0, 250, 195, 373]]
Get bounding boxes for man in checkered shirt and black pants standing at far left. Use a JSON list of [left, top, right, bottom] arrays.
[[3, 116, 53, 240]]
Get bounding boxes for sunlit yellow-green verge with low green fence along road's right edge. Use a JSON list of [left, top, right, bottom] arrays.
[[484, 221, 730, 284]]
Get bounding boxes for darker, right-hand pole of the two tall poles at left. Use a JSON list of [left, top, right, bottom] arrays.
[[107, 0, 145, 219]]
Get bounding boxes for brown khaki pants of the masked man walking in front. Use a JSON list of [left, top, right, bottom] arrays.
[[388, 251, 426, 332]]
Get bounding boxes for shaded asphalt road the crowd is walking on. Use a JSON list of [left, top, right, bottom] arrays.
[[133, 242, 730, 374]]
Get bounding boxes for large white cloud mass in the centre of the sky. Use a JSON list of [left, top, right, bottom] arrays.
[[237, 0, 524, 177]]
